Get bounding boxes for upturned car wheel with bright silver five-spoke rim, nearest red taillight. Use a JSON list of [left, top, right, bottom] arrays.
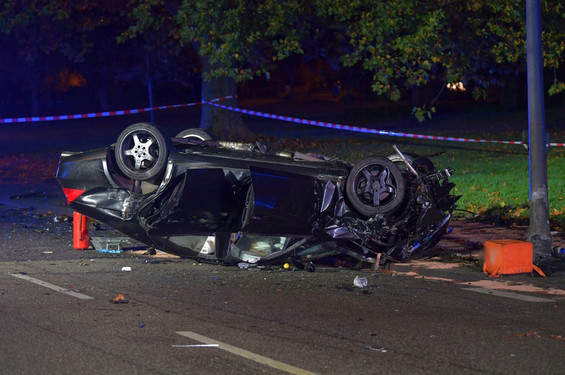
[[114, 122, 171, 181]]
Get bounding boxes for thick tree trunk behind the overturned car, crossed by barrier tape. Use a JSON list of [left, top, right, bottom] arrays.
[[200, 57, 253, 140]]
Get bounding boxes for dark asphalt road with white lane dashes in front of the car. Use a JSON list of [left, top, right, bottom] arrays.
[[0, 210, 565, 374]]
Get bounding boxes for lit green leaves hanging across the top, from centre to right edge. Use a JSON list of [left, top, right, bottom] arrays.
[[126, 0, 565, 122]]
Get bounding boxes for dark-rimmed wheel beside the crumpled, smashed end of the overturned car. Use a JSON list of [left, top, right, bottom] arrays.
[[345, 156, 406, 217]]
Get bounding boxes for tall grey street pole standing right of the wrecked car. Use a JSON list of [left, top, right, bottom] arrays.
[[526, 0, 552, 256]]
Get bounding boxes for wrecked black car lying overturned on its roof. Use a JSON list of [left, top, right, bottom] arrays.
[[57, 123, 457, 266]]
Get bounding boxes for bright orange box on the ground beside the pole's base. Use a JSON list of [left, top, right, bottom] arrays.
[[483, 240, 537, 277]]
